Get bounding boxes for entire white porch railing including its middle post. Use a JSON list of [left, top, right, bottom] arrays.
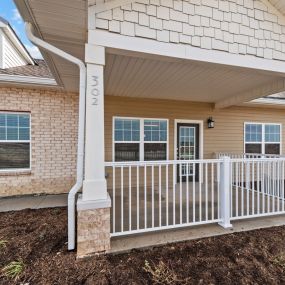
[[105, 157, 285, 236]]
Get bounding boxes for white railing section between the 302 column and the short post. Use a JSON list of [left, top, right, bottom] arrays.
[[106, 160, 221, 236]]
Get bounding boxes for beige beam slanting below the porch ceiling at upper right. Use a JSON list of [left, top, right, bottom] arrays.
[[215, 78, 285, 109]]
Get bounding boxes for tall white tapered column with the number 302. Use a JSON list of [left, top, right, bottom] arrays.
[[82, 44, 108, 201]]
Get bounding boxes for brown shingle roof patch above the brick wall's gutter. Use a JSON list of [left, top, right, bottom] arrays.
[[0, 59, 53, 79]]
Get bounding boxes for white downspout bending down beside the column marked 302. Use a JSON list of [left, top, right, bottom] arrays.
[[26, 23, 86, 250]]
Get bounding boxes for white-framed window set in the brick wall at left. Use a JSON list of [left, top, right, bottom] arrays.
[[0, 112, 30, 170]]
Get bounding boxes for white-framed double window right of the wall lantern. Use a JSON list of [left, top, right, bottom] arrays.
[[244, 123, 281, 154]]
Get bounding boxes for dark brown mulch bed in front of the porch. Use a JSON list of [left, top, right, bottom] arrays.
[[0, 209, 285, 285]]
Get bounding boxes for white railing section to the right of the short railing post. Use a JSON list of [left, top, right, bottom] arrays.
[[230, 158, 285, 219]]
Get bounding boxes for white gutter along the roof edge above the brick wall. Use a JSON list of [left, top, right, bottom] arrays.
[[0, 74, 58, 86]]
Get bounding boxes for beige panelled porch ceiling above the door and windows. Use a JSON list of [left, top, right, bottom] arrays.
[[105, 54, 281, 103]]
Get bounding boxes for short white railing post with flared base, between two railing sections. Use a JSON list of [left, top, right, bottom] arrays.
[[219, 156, 232, 229]]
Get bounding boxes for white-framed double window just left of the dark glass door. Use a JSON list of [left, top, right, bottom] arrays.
[[114, 117, 168, 161]]
